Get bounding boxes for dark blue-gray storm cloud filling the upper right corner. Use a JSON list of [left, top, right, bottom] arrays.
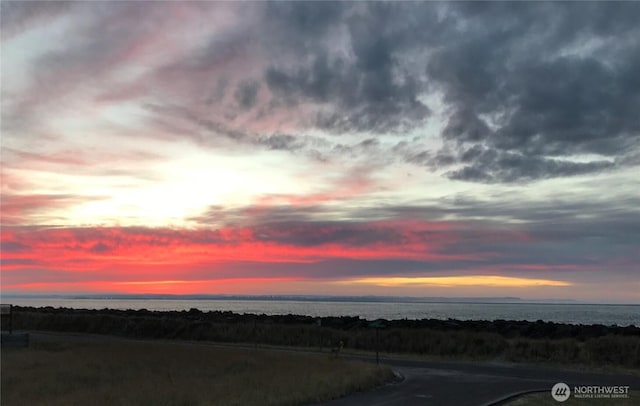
[[427, 3, 640, 182]]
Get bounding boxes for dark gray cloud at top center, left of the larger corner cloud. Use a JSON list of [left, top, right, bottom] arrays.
[[265, 2, 429, 133]]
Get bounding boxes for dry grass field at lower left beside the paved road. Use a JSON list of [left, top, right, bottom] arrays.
[[0, 339, 392, 406]]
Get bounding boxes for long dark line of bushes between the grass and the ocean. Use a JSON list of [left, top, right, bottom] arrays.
[[14, 307, 640, 368]]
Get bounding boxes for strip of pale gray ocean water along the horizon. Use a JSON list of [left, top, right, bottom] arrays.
[[2, 297, 640, 326]]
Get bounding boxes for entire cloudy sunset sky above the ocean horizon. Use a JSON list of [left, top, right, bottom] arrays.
[[0, 0, 640, 303]]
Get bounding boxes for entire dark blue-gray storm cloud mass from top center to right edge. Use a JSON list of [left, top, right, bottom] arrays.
[[256, 2, 640, 182]]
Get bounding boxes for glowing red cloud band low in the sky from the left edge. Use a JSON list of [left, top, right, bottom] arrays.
[[1, 222, 482, 291]]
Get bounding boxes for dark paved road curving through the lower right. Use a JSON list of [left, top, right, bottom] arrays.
[[322, 360, 640, 406]]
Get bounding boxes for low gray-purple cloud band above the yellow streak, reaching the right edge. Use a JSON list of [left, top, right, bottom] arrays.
[[188, 190, 640, 275]]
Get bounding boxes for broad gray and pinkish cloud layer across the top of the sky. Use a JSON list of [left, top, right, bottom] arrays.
[[2, 2, 640, 183]]
